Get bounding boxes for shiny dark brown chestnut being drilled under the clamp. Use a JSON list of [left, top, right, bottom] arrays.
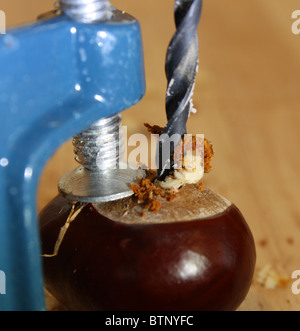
[[40, 185, 256, 311]]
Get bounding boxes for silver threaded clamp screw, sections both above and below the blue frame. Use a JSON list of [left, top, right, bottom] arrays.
[[58, 0, 120, 170]]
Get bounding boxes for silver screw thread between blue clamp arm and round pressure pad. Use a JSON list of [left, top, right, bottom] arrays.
[[73, 114, 124, 171]]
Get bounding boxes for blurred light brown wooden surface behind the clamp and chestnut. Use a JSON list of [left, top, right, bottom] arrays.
[[4, 0, 300, 311]]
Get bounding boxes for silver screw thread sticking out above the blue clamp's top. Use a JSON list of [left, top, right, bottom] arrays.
[[59, 0, 112, 23]]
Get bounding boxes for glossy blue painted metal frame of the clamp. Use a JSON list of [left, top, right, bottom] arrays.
[[0, 11, 145, 310]]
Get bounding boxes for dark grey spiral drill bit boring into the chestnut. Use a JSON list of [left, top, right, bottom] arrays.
[[157, 0, 202, 180]]
